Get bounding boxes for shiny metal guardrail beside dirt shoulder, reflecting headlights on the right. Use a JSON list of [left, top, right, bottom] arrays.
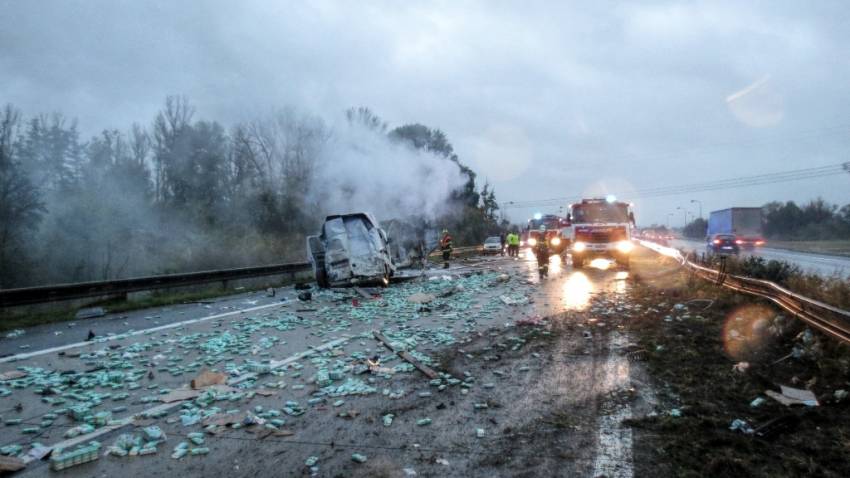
[[640, 241, 850, 343]]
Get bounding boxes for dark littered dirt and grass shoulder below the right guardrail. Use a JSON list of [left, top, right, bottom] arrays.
[[629, 273, 850, 478]]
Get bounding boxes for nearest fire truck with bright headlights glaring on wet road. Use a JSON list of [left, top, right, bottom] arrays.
[[567, 196, 635, 269]]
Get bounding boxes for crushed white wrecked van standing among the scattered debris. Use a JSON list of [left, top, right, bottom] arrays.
[[307, 212, 396, 287]]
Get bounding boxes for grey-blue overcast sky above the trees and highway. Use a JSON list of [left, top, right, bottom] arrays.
[[0, 0, 850, 225]]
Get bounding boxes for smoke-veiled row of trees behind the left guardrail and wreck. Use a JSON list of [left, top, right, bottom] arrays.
[[0, 97, 498, 288]]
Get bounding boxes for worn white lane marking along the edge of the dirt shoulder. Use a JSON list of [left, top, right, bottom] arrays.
[[592, 332, 634, 478]]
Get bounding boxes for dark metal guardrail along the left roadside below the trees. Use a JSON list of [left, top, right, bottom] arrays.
[[0, 262, 311, 308]]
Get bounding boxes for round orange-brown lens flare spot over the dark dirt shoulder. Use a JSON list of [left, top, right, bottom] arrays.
[[723, 304, 776, 360]]
